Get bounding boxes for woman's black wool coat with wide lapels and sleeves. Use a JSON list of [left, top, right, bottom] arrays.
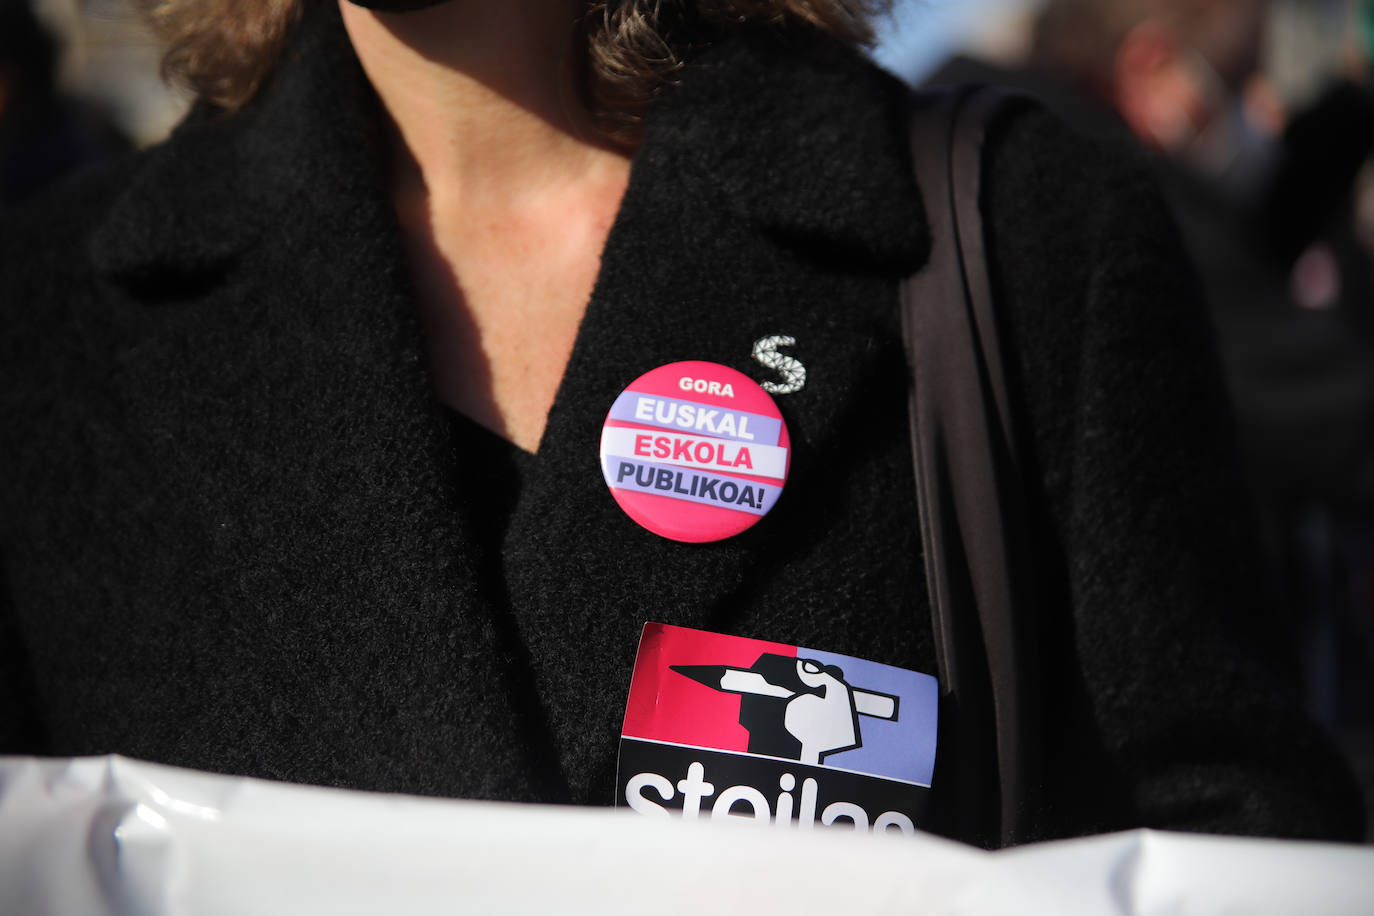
[[0, 3, 1359, 836]]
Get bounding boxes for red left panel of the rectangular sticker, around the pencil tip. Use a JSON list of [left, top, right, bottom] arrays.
[[621, 623, 797, 751]]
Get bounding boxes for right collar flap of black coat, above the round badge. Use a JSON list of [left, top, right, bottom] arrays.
[[644, 29, 929, 275]]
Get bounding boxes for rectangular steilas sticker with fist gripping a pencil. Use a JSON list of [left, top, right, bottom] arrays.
[[616, 623, 940, 835]]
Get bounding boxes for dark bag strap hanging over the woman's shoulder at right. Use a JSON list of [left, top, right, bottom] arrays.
[[901, 87, 1044, 846]]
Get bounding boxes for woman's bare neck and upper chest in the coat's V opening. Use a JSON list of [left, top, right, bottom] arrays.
[[341, 0, 629, 452]]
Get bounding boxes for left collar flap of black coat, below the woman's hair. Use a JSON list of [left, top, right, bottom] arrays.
[[92, 4, 385, 283]]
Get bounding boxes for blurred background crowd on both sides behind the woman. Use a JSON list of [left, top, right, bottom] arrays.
[[0, 0, 1374, 823]]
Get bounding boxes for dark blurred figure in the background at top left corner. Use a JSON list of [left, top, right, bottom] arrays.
[[0, 0, 129, 209]]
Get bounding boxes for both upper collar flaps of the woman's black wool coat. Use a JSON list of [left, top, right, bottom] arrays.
[[92, 4, 929, 282]]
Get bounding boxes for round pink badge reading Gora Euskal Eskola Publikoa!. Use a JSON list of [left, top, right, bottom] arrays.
[[600, 361, 791, 544]]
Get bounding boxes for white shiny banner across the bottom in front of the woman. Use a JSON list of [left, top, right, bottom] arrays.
[[0, 757, 1374, 916]]
